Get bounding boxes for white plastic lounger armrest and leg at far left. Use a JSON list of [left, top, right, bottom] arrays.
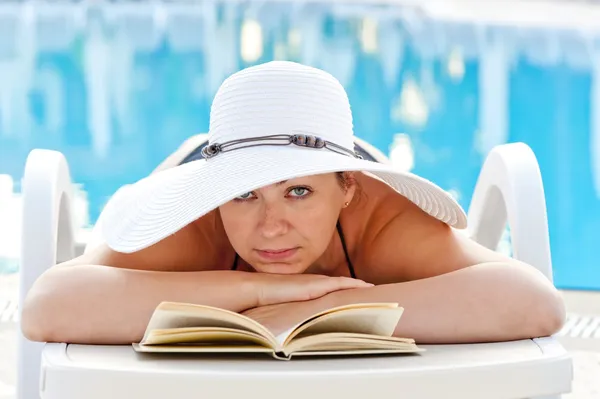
[[17, 149, 75, 399]]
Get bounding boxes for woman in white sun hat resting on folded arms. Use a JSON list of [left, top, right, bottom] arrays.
[[22, 62, 564, 344]]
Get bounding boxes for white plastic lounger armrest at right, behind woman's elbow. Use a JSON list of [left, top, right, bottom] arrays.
[[468, 143, 553, 281]]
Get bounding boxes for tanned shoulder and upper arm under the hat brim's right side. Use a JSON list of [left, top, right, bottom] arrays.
[[349, 172, 509, 284]]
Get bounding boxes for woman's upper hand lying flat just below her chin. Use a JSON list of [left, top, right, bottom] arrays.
[[253, 273, 373, 307]]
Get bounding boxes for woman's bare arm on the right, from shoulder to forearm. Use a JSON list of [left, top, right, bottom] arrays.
[[342, 204, 565, 342]]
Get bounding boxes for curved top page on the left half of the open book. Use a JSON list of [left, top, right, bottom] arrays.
[[141, 302, 277, 346]]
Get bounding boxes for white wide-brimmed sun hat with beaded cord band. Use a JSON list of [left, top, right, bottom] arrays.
[[102, 61, 467, 253]]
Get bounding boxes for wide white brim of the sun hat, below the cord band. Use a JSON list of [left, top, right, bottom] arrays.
[[102, 146, 467, 253]]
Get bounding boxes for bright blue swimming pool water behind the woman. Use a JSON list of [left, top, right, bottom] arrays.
[[0, 2, 600, 289]]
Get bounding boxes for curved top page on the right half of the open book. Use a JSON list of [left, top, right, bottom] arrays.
[[278, 305, 404, 346]]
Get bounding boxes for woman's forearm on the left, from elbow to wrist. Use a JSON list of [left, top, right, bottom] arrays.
[[21, 265, 257, 344]]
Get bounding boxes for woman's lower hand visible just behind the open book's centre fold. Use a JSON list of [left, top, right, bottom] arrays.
[[242, 298, 328, 336]]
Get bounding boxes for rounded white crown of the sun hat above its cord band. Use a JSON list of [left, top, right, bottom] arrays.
[[209, 61, 354, 150]]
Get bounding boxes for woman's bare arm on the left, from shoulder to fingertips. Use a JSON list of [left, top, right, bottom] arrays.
[[21, 226, 369, 344]]
